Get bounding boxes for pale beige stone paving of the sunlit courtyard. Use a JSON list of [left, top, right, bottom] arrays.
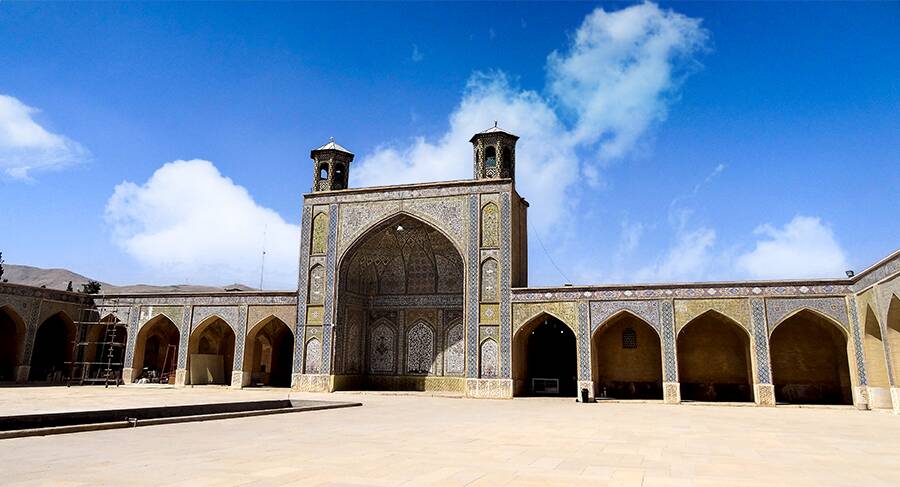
[[0, 387, 900, 487]]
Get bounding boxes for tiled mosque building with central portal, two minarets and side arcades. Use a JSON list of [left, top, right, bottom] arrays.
[[0, 125, 900, 411]]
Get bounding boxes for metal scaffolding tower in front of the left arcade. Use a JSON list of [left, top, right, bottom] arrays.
[[68, 302, 131, 387]]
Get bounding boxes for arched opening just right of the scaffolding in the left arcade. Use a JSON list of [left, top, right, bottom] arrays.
[[132, 314, 181, 384]]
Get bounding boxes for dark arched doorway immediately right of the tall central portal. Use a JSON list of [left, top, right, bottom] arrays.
[[513, 313, 578, 396]]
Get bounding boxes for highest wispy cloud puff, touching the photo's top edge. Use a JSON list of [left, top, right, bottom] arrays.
[[547, 3, 707, 159]]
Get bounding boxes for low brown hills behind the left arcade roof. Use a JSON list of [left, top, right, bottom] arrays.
[[3, 264, 256, 293]]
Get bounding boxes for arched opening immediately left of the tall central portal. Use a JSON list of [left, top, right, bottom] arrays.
[[244, 316, 294, 387]]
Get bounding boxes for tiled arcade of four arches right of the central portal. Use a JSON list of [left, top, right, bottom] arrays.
[[511, 294, 880, 407]]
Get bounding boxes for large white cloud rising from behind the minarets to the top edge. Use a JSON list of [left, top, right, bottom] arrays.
[[351, 3, 706, 235]]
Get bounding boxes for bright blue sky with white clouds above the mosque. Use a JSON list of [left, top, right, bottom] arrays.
[[0, 2, 900, 288]]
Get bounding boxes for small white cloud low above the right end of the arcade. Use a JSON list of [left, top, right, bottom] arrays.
[[736, 215, 849, 279]]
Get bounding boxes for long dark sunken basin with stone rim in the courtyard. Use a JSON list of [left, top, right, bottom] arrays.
[[0, 399, 362, 439]]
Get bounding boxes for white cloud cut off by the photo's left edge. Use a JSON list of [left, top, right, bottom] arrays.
[[0, 95, 88, 180]]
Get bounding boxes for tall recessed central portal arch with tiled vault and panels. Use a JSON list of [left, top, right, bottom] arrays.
[[336, 214, 465, 393]]
